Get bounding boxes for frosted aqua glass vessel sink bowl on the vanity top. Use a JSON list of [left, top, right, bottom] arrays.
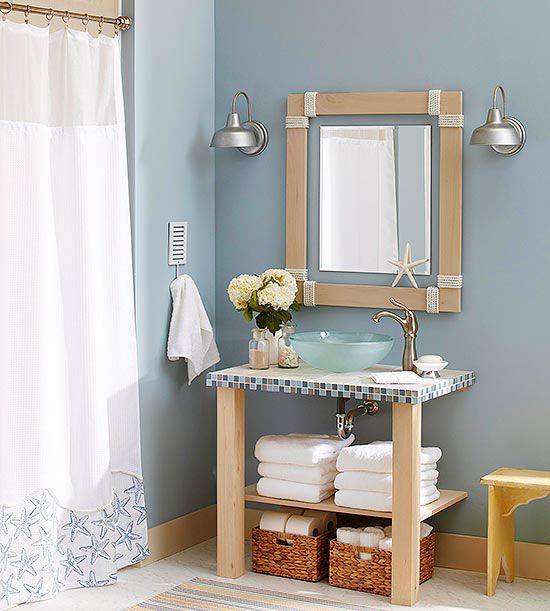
[[290, 331, 393, 373]]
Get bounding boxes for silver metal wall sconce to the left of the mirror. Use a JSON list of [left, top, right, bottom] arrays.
[[210, 91, 269, 156]]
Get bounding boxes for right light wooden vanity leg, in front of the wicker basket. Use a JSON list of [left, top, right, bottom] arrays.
[[391, 403, 422, 606]]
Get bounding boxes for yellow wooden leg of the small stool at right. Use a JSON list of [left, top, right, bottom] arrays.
[[487, 486, 514, 596]]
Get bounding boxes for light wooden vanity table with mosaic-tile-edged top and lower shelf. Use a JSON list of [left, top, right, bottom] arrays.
[[207, 364, 475, 606]]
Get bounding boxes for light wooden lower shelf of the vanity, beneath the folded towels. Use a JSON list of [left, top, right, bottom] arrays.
[[244, 484, 468, 520]]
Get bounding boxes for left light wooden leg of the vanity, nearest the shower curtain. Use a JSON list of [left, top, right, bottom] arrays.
[[217, 388, 245, 578]]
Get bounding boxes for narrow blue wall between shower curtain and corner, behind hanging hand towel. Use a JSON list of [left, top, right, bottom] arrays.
[[129, 0, 216, 526]]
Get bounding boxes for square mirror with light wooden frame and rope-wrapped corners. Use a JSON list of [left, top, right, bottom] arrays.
[[286, 90, 463, 313]]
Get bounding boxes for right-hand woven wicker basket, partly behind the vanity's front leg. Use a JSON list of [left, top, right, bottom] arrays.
[[329, 533, 435, 596]]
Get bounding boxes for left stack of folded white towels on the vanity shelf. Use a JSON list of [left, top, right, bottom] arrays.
[[254, 433, 355, 503]]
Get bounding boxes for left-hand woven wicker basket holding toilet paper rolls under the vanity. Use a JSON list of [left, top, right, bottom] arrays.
[[252, 528, 334, 581]]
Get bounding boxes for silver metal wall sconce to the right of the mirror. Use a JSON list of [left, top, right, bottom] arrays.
[[470, 85, 526, 157]]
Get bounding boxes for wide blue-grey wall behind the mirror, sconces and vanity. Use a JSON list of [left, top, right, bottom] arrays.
[[216, 0, 550, 542]]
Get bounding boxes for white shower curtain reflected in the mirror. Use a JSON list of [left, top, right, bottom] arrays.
[[320, 125, 398, 273]]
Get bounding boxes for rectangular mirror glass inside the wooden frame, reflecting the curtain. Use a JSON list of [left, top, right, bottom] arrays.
[[319, 125, 431, 274]]
